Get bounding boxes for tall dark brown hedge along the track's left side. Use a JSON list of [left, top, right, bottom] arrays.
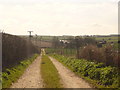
[[2, 34, 39, 71]]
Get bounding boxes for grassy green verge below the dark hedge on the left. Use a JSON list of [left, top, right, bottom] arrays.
[[2, 54, 38, 88]]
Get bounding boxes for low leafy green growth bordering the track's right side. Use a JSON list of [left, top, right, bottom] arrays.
[[52, 54, 120, 88]]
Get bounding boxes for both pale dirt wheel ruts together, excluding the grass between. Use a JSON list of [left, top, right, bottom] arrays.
[[11, 52, 92, 88]]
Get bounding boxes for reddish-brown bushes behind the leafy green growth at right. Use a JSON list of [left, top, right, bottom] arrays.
[[80, 45, 120, 67]]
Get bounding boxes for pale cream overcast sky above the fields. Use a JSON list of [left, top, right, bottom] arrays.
[[0, 0, 119, 35]]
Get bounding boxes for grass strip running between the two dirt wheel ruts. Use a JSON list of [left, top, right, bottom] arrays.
[[41, 55, 62, 88]]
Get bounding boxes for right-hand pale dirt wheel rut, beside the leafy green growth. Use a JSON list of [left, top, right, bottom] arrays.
[[49, 57, 92, 88]]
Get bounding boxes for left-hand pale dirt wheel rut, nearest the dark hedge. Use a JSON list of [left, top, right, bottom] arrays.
[[11, 56, 43, 88]]
